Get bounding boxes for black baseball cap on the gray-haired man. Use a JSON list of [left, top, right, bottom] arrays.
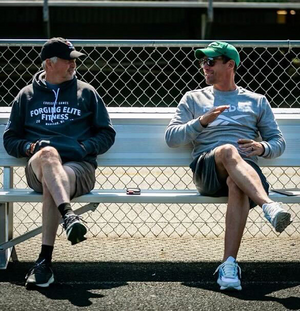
[[41, 37, 85, 61]]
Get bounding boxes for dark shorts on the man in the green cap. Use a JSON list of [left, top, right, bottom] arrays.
[[190, 149, 269, 208]]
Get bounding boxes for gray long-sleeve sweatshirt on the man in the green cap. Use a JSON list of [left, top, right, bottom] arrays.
[[165, 86, 285, 162]]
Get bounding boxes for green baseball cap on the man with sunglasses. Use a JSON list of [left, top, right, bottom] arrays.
[[195, 41, 241, 66]]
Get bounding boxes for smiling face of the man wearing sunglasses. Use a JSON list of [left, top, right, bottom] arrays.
[[200, 57, 227, 85]]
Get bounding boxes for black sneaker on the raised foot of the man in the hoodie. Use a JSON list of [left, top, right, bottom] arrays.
[[63, 214, 87, 245]]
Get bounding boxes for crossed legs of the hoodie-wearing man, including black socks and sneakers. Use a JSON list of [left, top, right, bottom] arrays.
[[25, 147, 86, 287]]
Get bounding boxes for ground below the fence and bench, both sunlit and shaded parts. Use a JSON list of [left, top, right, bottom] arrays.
[[0, 236, 300, 311]]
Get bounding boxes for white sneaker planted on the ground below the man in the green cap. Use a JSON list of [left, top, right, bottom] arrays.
[[214, 257, 242, 290]]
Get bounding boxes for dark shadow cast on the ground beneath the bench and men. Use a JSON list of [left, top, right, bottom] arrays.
[[0, 262, 300, 310]]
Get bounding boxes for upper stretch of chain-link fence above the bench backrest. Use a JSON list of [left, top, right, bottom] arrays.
[[0, 40, 300, 108]]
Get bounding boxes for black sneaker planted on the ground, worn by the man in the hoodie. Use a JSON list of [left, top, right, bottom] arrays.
[[25, 259, 54, 287]]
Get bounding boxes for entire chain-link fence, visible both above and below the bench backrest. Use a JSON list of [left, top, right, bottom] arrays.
[[0, 40, 300, 237]]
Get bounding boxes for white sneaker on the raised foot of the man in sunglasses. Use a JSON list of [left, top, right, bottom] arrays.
[[262, 202, 293, 232]]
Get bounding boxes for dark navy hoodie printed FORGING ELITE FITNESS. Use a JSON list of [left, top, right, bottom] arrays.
[[3, 71, 116, 167]]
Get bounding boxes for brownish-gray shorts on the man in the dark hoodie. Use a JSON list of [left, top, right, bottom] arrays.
[[25, 162, 96, 198]]
